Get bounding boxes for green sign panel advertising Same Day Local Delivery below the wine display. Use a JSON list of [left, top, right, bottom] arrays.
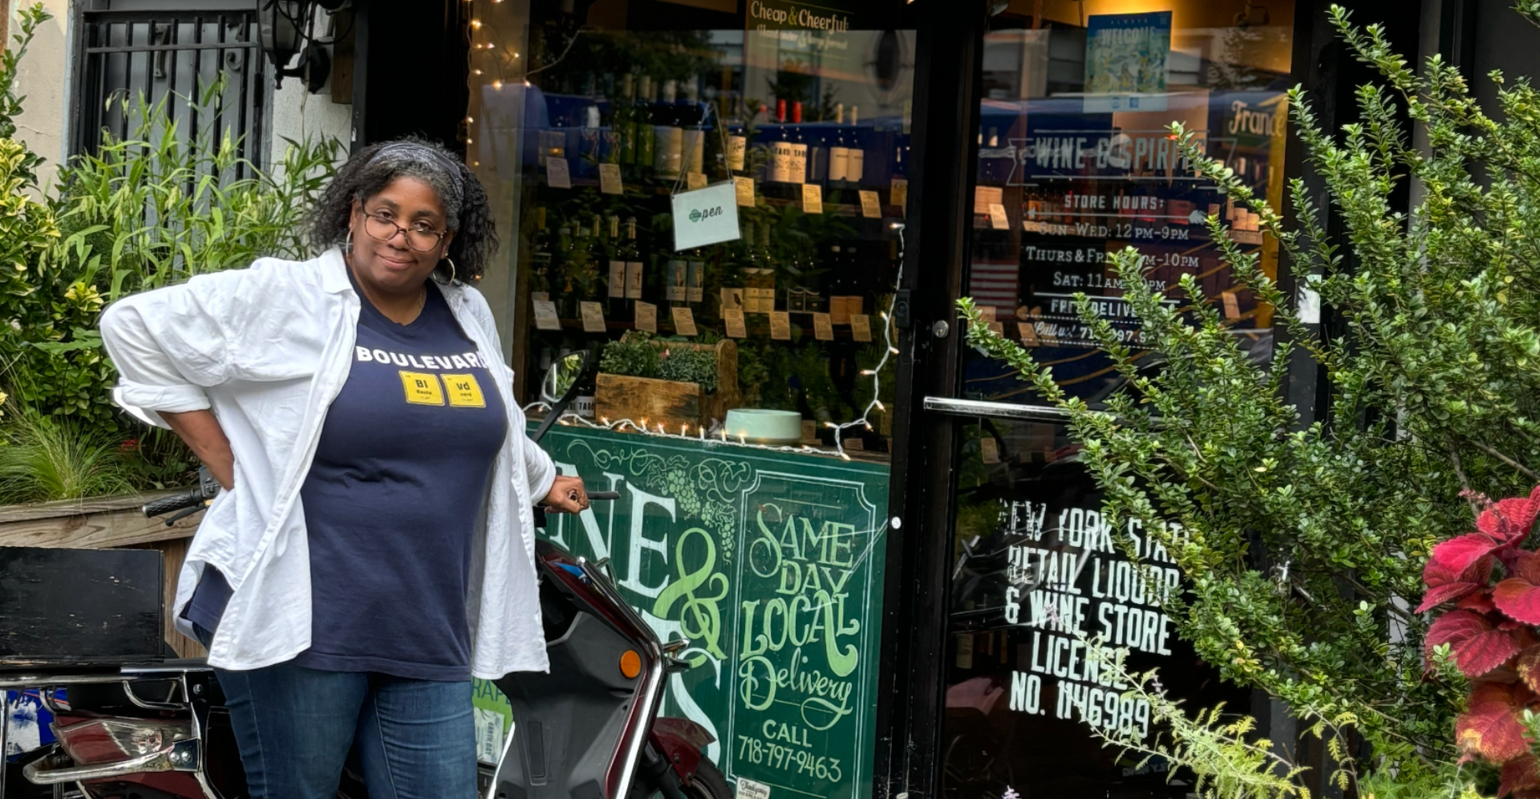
[[477, 428, 889, 799]]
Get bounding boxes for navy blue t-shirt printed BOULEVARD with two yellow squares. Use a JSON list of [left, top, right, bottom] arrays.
[[186, 276, 508, 680]]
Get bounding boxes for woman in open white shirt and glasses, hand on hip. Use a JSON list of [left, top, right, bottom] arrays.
[[102, 140, 588, 799]]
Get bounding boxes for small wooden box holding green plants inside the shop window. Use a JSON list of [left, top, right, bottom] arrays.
[[593, 339, 739, 433]]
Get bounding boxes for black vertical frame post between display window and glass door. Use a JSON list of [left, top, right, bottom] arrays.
[[873, 0, 989, 799]]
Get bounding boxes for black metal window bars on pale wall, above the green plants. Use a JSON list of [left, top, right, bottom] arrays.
[[71, 0, 271, 177]]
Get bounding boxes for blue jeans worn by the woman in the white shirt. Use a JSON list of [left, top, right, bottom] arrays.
[[214, 664, 476, 799]]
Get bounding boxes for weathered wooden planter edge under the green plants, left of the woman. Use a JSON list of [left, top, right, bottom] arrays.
[[0, 491, 203, 657]]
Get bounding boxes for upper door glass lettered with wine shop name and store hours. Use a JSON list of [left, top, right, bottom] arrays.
[[964, 0, 1294, 402]]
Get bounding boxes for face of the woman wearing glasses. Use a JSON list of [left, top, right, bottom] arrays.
[[348, 177, 454, 296]]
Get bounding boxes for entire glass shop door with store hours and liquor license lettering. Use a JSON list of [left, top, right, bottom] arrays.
[[926, 0, 1294, 799]]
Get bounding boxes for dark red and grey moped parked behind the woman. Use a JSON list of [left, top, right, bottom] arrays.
[[0, 351, 732, 799]]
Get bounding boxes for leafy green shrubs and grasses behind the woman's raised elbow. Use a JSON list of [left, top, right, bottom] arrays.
[[0, 5, 345, 488]]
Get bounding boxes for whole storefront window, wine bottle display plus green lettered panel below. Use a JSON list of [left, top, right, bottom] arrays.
[[465, 0, 916, 799]]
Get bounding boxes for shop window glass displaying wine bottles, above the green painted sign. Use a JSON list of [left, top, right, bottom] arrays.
[[467, 0, 915, 457]]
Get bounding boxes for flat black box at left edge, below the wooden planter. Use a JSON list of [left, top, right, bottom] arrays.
[[0, 547, 165, 667]]
